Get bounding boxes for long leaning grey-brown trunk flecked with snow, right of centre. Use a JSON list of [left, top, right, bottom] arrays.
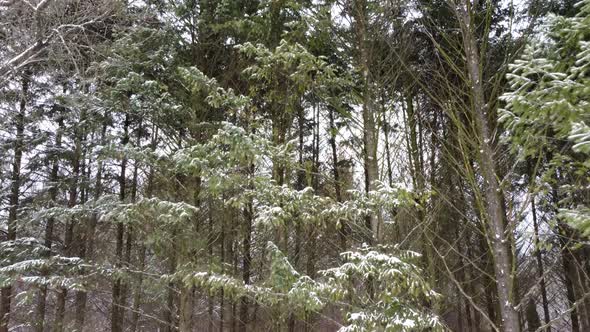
[[457, 0, 520, 332]]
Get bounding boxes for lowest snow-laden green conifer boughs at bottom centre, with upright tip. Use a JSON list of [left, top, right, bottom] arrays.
[[177, 242, 443, 331]]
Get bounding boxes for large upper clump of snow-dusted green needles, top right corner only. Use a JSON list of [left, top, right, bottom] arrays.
[[500, 1, 590, 156]]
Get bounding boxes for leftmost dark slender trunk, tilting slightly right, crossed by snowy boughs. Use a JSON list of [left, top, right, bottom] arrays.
[[0, 76, 29, 332]]
